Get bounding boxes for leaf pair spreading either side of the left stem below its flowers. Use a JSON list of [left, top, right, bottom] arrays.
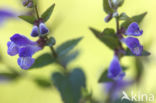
[[31, 37, 82, 69]]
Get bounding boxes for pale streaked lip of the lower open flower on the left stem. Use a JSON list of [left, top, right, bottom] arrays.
[[17, 57, 35, 70]]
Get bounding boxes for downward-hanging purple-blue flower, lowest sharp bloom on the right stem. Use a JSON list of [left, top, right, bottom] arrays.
[[107, 55, 125, 80]]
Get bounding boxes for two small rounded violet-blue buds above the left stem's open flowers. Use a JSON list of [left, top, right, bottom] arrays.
[[31, 22, 49, 37]]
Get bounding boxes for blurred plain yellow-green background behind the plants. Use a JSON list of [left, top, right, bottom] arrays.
[[0, 0, 156, 103]]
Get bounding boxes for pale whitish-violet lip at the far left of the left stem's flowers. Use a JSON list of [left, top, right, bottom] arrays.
[[7, 41, 19, 56]]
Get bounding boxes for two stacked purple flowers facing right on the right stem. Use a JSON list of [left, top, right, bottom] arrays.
[[121, 22, 143, 56]]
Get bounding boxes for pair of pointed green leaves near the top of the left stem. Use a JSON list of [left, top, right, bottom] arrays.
[[19, 4, 55, 24]]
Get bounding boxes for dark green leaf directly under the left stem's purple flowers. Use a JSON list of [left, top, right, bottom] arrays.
[[30, 53, 55, 69]]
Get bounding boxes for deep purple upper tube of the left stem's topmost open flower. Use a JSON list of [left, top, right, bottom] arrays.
[[10, 34, 37, 46]]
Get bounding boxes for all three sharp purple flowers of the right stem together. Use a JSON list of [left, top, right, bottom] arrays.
[[107, 22, 143, 80]]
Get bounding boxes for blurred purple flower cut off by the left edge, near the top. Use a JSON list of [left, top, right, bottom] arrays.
[[0, 9, 16, 24]]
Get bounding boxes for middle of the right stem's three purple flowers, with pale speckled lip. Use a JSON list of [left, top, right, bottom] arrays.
[[122, 37, 143, 56]]
